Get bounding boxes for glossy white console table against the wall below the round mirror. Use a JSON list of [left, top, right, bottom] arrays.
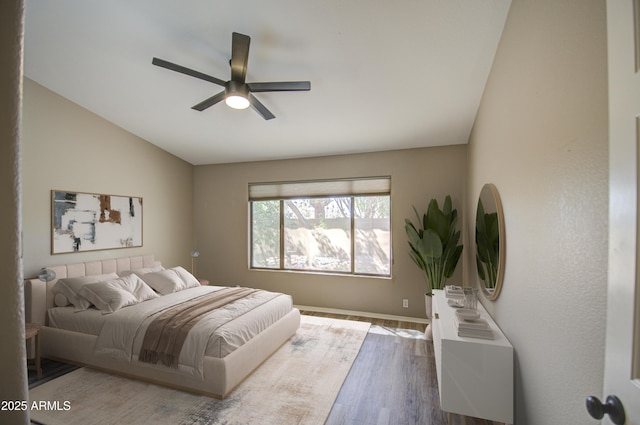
[[431, 290, 514, 424]]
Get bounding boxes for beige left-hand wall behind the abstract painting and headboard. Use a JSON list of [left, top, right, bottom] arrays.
[[22, 78, 193, 276]]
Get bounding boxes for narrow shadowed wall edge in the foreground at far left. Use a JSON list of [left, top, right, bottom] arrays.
[[0, 1, 29, 425]]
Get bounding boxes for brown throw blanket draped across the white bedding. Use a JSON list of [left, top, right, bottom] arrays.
[[138, 288, 259, 368]]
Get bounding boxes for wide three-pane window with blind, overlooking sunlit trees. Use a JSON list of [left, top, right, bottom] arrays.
[[249, 177, 391, 276]]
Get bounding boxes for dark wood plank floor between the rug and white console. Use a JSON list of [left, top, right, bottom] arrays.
[[301, 311, 498, 425]]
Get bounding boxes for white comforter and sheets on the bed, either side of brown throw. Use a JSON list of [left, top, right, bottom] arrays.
[[49, 286, 292, 378]]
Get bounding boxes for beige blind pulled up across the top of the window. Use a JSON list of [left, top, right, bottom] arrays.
[[249, 176, 391, 201]]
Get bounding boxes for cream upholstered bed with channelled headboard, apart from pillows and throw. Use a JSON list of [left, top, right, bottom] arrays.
[[25, 255, 300, 398]]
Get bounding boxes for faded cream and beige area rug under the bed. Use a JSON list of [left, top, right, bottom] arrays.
[[29, 316, 370, 425]]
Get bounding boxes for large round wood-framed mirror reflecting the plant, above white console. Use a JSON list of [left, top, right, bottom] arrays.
[[476, 183, 506, 301]]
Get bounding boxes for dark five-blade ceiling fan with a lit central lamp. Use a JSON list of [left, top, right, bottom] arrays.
[[151, 32, 311, 120]]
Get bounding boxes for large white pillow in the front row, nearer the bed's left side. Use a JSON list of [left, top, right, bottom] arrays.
[[78, 274, 158, 314]]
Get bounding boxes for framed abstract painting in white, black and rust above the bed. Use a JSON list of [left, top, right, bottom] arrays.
[[51, 190, 142, 254]]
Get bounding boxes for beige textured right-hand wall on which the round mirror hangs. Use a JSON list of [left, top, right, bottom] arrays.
[[465, 0, 608, 425]]
